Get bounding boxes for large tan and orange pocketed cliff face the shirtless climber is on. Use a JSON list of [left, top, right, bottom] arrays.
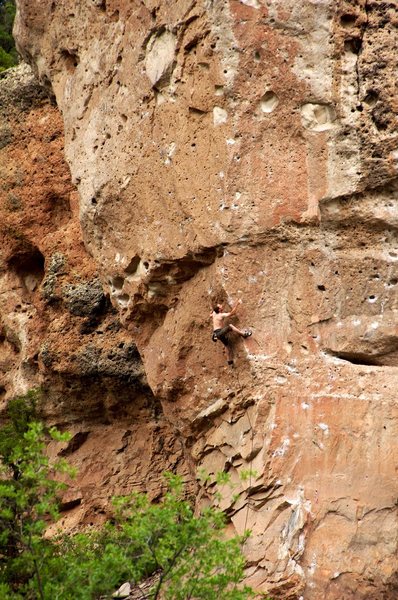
[[7, 0, 398, 600]]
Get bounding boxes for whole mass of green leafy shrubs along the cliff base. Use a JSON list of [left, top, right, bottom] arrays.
[[0, 393, 254, 600]]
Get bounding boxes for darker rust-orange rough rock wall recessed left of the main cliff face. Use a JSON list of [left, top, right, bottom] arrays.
[[0, 65, 189, 527]]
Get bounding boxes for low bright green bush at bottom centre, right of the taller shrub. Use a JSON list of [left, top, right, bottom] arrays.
[[35, 474, 254, 600]]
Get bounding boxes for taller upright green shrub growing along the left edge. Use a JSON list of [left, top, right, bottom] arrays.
[[0, 392, 70, 598]]
